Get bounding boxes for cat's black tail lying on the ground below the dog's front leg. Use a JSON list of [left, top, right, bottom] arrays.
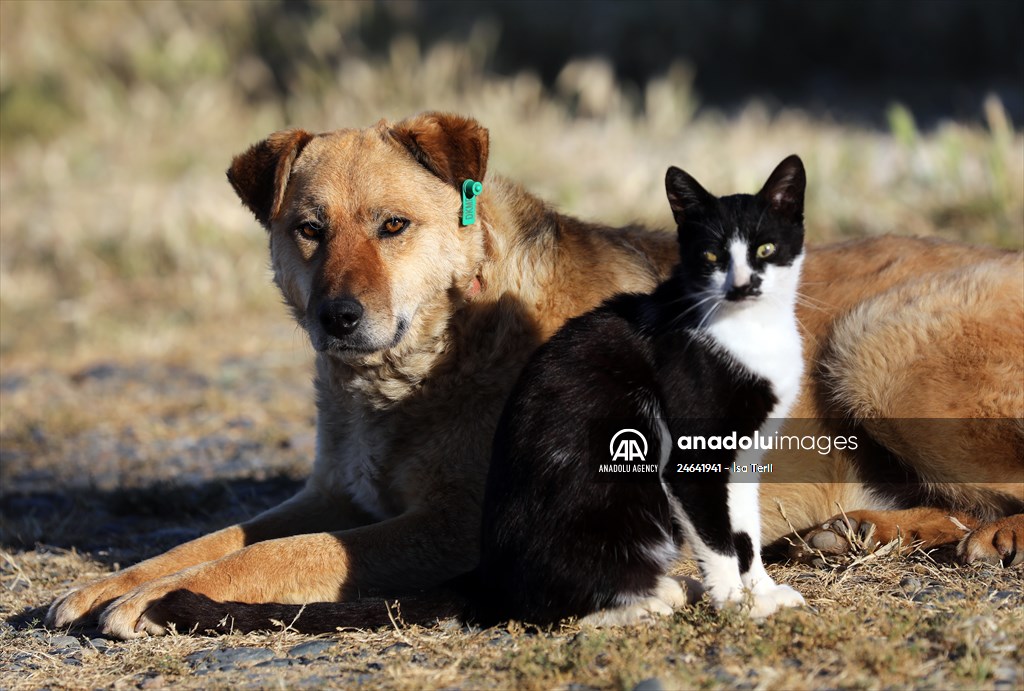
[[147, 588, 467, 634]]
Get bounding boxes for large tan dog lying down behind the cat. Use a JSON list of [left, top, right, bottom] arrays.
[[47, 114, 1024, 638]]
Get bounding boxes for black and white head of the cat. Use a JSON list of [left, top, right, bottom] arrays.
[[665, 155, 807, 309]]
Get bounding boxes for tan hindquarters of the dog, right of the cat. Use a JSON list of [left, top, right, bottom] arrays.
[[761, 237, 1024, 565]]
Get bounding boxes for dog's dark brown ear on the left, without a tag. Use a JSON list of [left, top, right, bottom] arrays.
[[227, 130, 313, 229]]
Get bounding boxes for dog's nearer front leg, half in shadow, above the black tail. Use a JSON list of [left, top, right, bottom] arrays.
[[100, 505, 478, 639]]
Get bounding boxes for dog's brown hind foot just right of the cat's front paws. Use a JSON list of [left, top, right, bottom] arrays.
[[790, 508, 978, 561]]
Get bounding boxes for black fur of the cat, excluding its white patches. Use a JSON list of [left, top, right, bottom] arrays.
[[472, 157, 804, 623]]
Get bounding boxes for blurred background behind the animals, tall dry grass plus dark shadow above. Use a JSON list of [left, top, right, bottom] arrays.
[[0, 0, 1024, 369]]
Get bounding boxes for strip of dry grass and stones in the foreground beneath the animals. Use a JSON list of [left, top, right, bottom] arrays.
[[0, 551, 1024, 689]]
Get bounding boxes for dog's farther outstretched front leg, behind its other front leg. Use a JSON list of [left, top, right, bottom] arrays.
[[46, 490, 353, 629]]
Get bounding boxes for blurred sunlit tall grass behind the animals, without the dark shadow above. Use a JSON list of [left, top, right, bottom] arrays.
[[0, 2, 1024, 363]]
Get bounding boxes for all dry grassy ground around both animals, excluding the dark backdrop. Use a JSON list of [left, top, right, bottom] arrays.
[[0, 2, 1024, 689]]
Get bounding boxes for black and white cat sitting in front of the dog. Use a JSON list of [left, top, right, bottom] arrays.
[[472, 156, 805, 624]]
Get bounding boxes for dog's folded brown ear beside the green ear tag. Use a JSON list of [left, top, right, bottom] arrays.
[[387, 113, 489, 187]]
